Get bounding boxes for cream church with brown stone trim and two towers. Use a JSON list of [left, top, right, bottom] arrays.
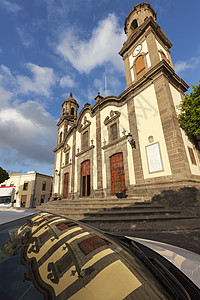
[[53, 2, 200, 200]]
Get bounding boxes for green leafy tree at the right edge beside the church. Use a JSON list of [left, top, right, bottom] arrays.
[[178, 80, 200, 138]]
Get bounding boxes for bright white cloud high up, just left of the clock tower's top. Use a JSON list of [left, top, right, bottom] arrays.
[[57, 14, 125, 73]]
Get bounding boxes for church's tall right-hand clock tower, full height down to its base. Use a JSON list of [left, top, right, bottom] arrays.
[[119, 2, 200, 195]]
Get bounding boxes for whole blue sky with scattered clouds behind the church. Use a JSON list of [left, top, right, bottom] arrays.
[[0, 0, 200, 174]]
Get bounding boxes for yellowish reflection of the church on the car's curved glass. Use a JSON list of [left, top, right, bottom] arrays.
[[1, 212, 173, 300]]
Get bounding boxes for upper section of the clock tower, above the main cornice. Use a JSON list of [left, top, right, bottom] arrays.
[[119, 2, 173, 88]]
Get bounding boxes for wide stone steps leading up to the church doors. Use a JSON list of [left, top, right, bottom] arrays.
[[36, 197, 197, 231]]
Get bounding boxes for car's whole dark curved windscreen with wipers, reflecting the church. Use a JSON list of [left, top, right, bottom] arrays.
[[0, 212, 200, 300]]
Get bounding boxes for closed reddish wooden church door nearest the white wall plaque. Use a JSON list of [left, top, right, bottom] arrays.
[[110, 153, 126, 195]]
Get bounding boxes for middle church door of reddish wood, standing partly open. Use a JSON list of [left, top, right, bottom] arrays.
[[81, 160, 90, 197]]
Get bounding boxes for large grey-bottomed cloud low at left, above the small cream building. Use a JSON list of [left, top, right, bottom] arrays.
[[0, 100, 57, 164]]
